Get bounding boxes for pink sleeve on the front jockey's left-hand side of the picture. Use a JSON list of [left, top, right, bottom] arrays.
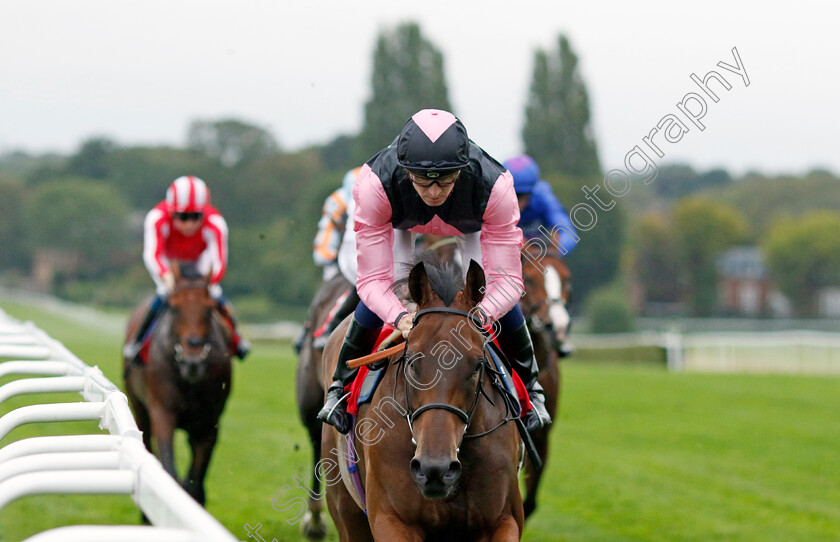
[[353, 165, 405, 324]]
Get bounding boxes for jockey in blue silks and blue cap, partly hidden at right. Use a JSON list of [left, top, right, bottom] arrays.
[[504, 154, 580, 357]]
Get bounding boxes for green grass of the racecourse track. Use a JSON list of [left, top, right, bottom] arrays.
[[0, 304, 840, 542]]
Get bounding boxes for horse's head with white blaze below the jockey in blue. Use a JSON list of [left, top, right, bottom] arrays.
[[520, 247, 572, 340]]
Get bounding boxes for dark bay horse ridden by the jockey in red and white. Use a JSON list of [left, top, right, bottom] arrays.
[[123, 262, 232, 505]]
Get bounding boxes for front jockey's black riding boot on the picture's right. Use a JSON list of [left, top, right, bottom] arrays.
[[498, 324, 551, 431]]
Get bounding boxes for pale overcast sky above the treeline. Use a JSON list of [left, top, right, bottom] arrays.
[[0, 0, 840, 173]]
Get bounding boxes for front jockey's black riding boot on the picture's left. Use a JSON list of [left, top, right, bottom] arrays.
[[318, 317, 380, 434]]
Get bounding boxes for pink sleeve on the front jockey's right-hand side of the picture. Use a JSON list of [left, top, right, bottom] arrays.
[[478, 171, 525, 320]]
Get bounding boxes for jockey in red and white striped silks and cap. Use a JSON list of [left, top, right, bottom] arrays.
[[124, 176, 250, 361]]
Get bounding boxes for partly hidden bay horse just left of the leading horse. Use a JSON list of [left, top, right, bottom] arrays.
[[295, 273, 352, 540]]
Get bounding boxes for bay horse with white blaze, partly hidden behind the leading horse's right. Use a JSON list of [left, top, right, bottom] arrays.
[[519, 245, 572, 519]]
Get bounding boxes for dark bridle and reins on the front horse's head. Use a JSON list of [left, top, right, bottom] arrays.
[[394, 307, 518, 447]]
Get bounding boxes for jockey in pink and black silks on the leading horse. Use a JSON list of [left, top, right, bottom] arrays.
[[318, 109, 550, 432]]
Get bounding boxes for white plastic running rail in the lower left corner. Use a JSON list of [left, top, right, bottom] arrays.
[[0, 309, 236, 542]]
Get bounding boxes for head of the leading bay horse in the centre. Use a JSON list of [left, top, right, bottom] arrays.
[[405, 261, 487, 498]]
